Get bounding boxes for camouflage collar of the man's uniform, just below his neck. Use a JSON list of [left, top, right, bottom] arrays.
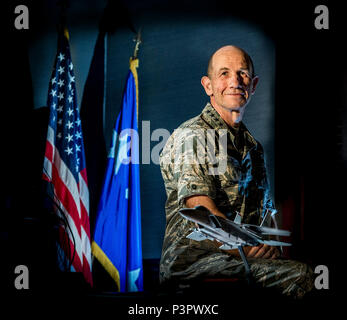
[[201, 102, 257, 155]]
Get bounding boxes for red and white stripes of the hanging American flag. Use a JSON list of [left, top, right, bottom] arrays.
[[43, 126, 92, 285]]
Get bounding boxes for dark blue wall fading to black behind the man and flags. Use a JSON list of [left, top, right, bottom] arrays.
[[0, 1, 347, 296]]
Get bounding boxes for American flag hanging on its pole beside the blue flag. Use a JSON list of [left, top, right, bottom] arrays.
[[43, 30, 92, 285]]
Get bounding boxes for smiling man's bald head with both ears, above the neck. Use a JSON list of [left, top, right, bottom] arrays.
[[201, 46, 258, 112]]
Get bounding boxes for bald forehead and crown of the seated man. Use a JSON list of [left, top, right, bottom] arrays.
[[212, 49, 250, 71]]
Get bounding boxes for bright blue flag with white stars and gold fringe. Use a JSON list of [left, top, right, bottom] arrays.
[[92, 59, 143, 292]]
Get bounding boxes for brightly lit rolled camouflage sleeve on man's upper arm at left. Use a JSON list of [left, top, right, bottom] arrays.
[[174, 128, 216, 206]]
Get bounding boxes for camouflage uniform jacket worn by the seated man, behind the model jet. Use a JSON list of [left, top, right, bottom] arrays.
[[160, 103, 274, 281]]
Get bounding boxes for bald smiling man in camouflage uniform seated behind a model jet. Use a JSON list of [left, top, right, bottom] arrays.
[[160, 46, 313, 297]]
